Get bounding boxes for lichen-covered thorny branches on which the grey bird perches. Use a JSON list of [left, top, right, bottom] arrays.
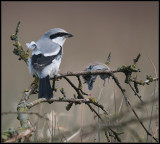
[[2, 22, 159, 142]]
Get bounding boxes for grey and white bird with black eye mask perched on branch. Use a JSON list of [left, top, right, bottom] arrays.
[[26, 28, 73, 99]]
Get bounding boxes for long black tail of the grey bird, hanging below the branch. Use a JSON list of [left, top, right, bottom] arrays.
[[38, 76, 53, 99]]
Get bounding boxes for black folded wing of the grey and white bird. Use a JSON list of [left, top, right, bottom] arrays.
[[32, 47, 62, 71]]
